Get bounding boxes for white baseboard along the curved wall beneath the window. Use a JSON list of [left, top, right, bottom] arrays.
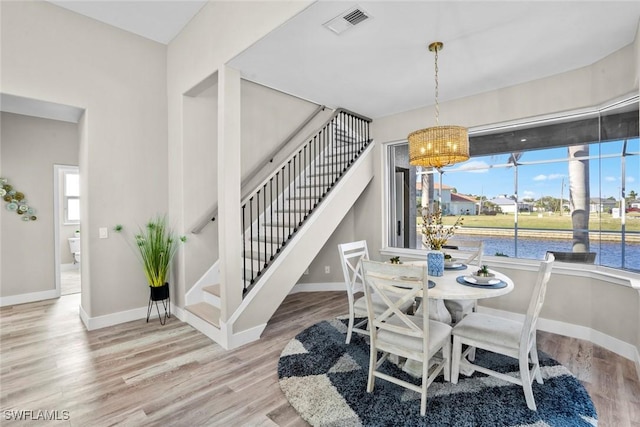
[[478, 306, 640, 366]]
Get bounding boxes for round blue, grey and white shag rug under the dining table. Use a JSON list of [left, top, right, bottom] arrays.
[[278, 319, 598, 427]]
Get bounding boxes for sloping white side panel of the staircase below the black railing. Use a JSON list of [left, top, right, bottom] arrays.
[[225, 142, 375, 348]]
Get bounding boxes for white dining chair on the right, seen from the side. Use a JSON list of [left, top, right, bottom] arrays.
[[451, 254, 554, 411]]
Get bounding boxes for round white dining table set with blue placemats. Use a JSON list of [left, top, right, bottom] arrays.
[[405, 260, 513, 324]]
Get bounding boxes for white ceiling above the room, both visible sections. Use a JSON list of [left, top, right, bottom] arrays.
[[18, 0, 640, 122]]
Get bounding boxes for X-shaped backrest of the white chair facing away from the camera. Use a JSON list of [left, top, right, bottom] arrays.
[[362, 260, 429, 340]]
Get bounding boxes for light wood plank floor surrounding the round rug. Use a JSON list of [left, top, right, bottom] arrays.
[[0, 292, 640, 427]]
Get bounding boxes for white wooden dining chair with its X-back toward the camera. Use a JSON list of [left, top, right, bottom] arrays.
[[362, 260, 451, 416]]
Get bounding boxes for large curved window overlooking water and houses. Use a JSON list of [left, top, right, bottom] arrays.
[[388, 97, 640, 271]]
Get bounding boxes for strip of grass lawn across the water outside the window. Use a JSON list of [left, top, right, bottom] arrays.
[[424, 213, 640, 231]]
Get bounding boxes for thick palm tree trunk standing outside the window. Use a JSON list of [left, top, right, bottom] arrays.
[[560, 144, 590, 252]]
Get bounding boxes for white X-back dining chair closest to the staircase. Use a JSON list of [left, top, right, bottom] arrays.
[[338, 240, 412, 344]]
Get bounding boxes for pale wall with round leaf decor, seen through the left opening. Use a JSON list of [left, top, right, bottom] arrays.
[[0, 113, 79, 298]]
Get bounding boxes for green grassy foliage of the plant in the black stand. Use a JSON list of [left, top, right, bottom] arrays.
[[113, 216, 187, 287]]
